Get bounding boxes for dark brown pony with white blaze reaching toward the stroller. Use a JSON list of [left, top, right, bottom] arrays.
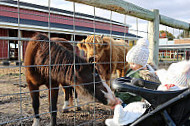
[[24, 34, 117, 126]]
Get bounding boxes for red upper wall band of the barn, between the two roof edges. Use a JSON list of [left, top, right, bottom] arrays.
[[0, 5, 128, 33]]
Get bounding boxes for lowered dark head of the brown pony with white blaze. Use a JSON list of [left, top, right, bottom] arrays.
[[77, 64, 117, 106]]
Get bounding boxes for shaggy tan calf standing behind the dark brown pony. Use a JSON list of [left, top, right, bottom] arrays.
[[77, 35, 129, 85]]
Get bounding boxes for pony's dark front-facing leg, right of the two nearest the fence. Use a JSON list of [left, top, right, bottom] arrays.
[[49, 86, 59, 126]]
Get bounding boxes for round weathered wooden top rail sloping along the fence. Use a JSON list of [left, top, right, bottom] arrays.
[[67, 0, 190, 30]]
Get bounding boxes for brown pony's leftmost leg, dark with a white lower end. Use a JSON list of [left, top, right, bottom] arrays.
[[28, 81, 40, 126]]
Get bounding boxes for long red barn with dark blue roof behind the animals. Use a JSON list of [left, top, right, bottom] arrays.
[[0, 0, 140, 60]]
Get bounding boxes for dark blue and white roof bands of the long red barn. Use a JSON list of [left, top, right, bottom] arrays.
[[0, 0, 140, 39]]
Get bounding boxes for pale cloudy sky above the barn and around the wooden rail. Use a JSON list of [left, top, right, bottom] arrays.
[[20, 0, 190, 38]]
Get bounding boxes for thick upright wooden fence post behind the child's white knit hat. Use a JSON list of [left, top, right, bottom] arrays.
[[148, 9, 160, 65]]
